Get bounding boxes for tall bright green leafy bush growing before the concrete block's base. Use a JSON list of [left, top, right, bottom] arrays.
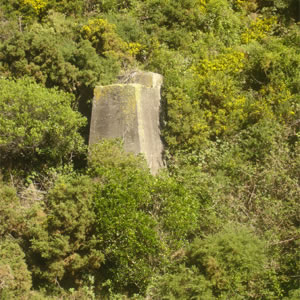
[[89, 140, 161, 294]]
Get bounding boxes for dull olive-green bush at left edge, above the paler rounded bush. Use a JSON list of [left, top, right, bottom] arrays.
[[0, 25, 110, 94]]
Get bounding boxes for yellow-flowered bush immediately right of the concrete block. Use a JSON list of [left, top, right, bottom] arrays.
[[166, 48, 247, 149]]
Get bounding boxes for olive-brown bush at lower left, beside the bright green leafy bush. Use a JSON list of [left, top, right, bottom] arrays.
[[28, 175, 99, 288]]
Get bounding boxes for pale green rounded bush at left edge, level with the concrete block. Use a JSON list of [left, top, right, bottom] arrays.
[[0, 78, 85, 169]]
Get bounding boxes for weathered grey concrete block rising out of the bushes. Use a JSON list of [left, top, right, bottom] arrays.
[[89, 72, 163, 174]]
